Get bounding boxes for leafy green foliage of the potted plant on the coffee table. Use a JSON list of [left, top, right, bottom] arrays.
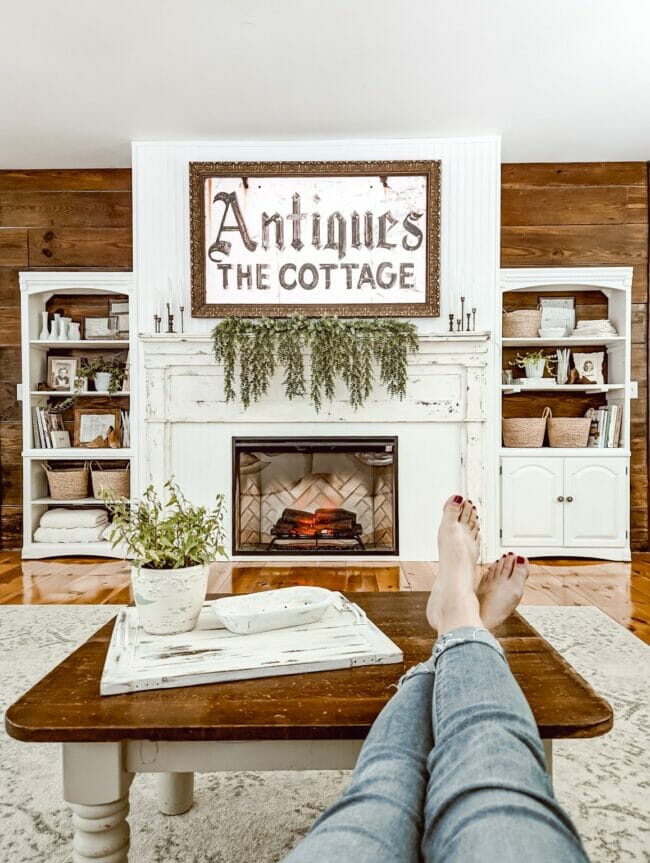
[[103, 479, 226, 569]]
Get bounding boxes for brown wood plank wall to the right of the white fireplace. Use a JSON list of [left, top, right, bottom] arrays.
[[501, 162, 648, 550]]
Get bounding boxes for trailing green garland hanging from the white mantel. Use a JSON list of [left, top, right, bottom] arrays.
[[212, 315, 418, 411]]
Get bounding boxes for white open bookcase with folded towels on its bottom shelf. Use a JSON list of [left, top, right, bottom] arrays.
[[20, 272, 137, 559]]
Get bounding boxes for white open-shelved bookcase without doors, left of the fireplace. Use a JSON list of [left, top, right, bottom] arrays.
[[20, 272, 137, 559]]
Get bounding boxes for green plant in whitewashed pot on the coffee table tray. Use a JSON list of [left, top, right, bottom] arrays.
[[104, 479, 226, 635]]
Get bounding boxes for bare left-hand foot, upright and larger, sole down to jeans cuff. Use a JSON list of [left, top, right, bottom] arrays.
[[427, 495, 483, 636]]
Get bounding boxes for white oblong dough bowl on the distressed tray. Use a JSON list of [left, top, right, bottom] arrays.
[[210, 587, 336, 635]]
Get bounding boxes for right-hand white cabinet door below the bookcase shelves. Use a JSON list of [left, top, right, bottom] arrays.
[[564, 458, 628, 548]]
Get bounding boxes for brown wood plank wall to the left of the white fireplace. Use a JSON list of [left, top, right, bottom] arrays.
[[0, 170, 131, 548]]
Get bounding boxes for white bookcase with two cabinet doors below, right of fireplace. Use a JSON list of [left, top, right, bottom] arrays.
[[495, 267, 637, 560]]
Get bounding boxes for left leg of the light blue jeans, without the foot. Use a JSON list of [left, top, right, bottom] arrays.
[[285, 663, 433, 863]]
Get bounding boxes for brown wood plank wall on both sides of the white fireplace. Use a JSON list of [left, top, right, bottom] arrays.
[[0, 162, 648, 548]]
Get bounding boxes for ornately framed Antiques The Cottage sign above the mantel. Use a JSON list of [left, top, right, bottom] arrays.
[[190, 161, 440, 317]]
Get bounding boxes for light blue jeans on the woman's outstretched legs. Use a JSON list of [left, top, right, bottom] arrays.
[[285, 627, 588, 863]]
